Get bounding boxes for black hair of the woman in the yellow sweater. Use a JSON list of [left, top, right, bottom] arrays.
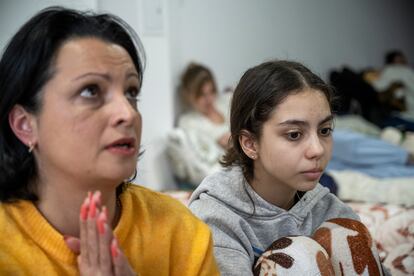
[[0, 7, 145, 202]]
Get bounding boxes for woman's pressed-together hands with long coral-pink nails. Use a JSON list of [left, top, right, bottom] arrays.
[[65, 191, 136, 276]]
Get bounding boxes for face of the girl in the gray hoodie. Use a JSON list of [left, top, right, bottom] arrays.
[[254, 88, 333, 191]]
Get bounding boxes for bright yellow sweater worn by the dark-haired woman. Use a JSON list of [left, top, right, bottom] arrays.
[[0, 186, 219, 276]]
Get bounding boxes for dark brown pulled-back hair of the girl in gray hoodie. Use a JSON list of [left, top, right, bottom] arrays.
[[220, 60, 334, 180]]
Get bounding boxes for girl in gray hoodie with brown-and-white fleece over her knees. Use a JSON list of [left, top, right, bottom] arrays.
[[190, 61, 390, 276]]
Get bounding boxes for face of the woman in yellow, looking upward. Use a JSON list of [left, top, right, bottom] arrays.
[[30, 38, 141, 184]]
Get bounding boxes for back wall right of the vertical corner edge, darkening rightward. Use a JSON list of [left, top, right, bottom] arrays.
[[171, 0, 414, 91]]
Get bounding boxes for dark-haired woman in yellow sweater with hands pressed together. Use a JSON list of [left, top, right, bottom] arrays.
[[0, 7, 217, 275]]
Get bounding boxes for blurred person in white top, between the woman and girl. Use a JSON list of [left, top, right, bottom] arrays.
[[178, 63, 230, 149]]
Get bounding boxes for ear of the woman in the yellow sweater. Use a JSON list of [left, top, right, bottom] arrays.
[[9, 104, 37, 148]]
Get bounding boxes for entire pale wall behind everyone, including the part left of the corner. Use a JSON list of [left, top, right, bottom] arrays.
[[0, 0, 414, 190]]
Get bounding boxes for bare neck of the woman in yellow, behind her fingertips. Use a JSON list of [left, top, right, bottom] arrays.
[[35, 177, 116, 237]]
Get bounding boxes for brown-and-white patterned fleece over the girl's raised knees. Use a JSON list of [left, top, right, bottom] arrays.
[[254, 218, 388, 276]]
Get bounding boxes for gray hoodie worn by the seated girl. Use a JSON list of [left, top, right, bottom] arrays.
[[190, 167, 359, 276]]
